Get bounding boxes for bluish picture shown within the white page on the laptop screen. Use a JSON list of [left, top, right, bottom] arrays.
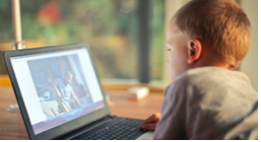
[[28, 54, 93, 119]]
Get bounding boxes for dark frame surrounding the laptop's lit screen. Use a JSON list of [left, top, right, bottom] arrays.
[[4, 43, 110, 139]]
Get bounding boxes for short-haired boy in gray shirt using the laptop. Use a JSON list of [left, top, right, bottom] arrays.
[[141, 0, 258, 139]]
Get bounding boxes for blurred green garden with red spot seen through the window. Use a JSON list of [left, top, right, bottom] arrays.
[[0, 0, 165, 80]]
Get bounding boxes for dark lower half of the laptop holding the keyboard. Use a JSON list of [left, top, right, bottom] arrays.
[[61, 116, 147, 140]]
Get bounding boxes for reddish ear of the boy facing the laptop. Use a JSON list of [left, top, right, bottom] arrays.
[[188, 39, 202, 64]]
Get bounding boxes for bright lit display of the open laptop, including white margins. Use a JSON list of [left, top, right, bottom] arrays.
[[10, 48, 105, 135]]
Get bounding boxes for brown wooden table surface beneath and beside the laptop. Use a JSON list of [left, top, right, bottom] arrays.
[[0, 87, 163, 140]]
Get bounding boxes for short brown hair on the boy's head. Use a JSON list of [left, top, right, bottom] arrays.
[[172, 0, 250, 68]]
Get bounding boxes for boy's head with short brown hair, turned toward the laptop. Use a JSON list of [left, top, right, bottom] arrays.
[[167, 0, 250, 80]]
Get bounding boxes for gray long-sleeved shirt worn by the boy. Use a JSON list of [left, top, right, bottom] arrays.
[[154, 67, 258, 139]]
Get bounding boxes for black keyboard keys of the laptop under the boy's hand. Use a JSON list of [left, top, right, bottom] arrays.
[[83, 118, 146, 140]]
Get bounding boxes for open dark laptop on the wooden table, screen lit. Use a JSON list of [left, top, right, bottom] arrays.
[[4, 43, 150, 140]]
